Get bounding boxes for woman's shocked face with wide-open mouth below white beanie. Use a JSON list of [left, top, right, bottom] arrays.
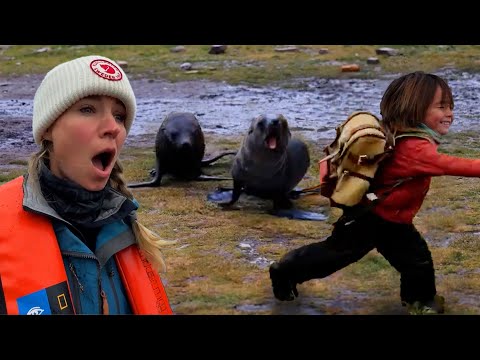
[[44, 96, 127, 191]]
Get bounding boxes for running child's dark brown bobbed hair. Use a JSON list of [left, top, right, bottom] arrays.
[[380, 71, 453, 134]]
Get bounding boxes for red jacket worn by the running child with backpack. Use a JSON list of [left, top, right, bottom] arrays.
[[373, 137, 480, 223]]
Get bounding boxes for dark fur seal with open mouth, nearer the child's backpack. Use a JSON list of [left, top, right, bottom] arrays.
[[211, 115, 310, 214]]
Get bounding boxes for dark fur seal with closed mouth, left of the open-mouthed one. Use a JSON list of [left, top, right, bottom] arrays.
[[128, 112, 236, 188]]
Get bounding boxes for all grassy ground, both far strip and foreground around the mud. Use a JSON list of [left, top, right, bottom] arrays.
[[0, 45, 480, 314]]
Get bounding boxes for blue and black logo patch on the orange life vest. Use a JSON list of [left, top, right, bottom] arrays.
[[17, 281, 74, 315]]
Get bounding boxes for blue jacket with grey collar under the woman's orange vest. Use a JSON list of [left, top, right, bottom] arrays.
[[23, 174, 138, 314]]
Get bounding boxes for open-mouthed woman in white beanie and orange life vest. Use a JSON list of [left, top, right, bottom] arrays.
[[0, 56, 172, 315]]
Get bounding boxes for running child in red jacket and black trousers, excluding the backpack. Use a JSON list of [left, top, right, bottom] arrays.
[[270, 72, 480, 314]]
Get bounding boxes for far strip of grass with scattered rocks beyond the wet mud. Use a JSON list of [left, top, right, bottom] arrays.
[[0, 45, 480, 85]]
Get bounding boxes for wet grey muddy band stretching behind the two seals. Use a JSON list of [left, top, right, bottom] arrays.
[[0, 70, 480, 157]]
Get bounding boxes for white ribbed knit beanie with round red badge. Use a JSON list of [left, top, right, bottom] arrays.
[[32, 55, 136, 144]]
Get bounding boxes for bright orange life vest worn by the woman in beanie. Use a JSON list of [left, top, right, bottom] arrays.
[[0, 176, 173, 315]]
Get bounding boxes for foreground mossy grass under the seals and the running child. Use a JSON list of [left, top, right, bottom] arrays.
[[124, 133, 480, 314]]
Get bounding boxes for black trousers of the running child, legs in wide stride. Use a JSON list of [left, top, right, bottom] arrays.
[[278, 212, 436, 303]]
